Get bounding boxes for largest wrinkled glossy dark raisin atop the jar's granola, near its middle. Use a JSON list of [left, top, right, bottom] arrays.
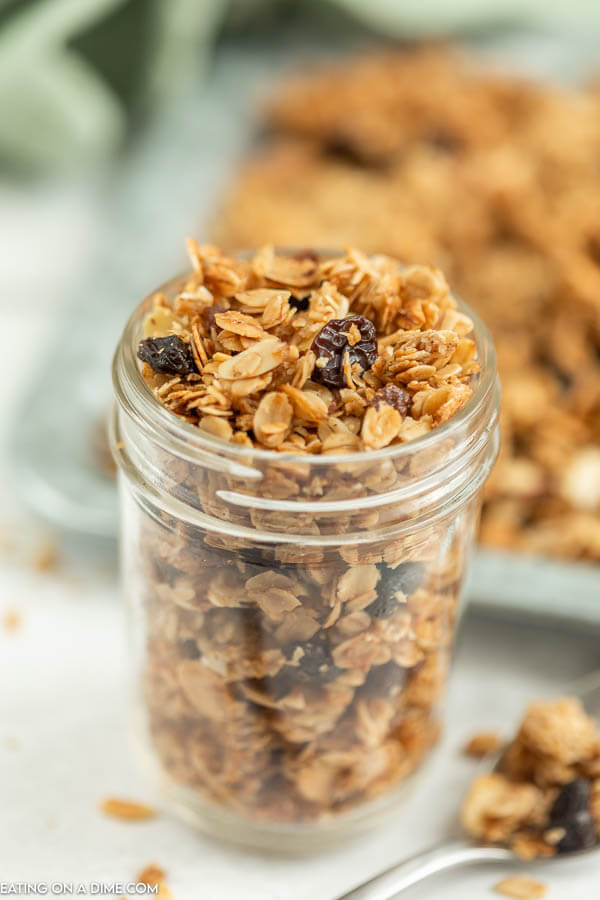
[[312, 316, 377, 388]]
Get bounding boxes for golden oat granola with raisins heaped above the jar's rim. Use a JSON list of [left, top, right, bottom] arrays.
[[138, 241, 479, 454]]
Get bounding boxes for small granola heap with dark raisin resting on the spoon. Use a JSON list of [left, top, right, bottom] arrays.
[[462, 697, 600, 859]]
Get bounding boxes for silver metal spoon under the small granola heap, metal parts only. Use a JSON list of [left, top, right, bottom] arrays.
[[336, 672, 600, 900]]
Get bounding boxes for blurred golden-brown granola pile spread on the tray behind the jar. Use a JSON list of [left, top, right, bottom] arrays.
[[214, 48, 600, 560]]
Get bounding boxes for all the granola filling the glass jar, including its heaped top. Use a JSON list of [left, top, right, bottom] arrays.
[[126, 242, 479, 822]]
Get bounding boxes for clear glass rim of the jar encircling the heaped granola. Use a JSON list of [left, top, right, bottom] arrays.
[[112, 262, 497, 466]]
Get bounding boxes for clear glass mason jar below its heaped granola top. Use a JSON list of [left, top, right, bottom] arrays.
[[112, 262, 498, 851]]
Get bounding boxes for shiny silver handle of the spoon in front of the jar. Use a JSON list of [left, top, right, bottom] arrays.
[[337, 841, 514, 900]]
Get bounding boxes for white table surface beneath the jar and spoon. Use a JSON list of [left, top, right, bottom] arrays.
[[0, 178, 600, 900]]
